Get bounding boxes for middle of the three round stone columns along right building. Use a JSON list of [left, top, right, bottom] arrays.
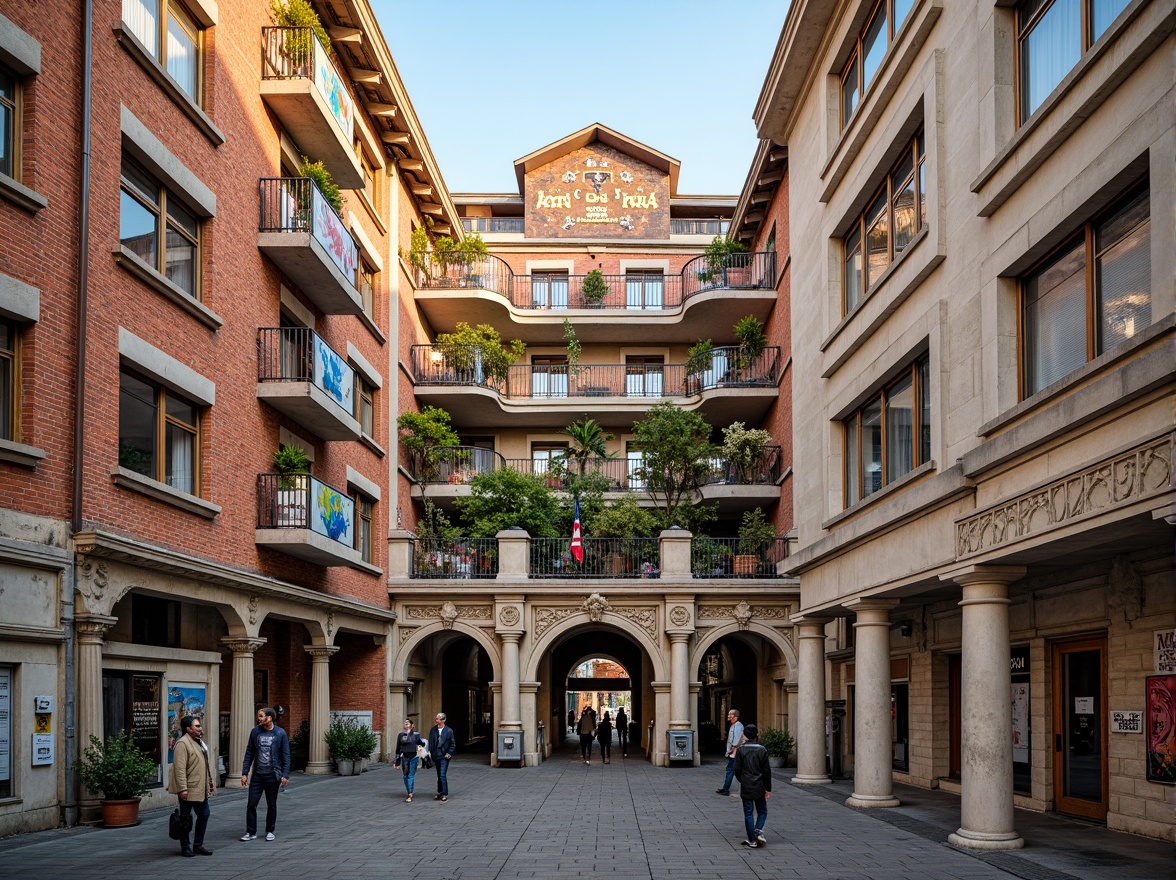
[[846, 599, 898, 807]]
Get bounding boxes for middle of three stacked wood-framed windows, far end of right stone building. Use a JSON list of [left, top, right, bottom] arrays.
[[842, 132, 927, 315]]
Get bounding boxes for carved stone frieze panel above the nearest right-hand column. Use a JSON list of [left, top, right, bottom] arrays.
[[956, 436, 1172, 559]]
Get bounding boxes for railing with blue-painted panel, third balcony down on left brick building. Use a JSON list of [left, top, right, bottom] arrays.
[[258, 327, 355, 416]]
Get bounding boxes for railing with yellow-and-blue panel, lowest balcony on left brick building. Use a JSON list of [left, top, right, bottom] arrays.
[[258, 474, 355, 547]]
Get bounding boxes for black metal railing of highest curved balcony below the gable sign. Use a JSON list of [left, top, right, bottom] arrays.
[[415, 251, 776, 312]]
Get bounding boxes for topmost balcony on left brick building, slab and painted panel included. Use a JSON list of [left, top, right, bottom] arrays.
[[261, 27, 363, 189]]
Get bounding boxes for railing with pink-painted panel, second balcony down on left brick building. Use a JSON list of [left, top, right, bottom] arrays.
[[258, 178, 360, 287]]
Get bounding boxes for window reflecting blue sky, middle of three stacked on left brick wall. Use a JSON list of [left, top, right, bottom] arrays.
[[119, 158, 200, 299]]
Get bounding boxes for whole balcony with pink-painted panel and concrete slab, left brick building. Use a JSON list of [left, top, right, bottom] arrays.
[[258, 178, 363, 315]]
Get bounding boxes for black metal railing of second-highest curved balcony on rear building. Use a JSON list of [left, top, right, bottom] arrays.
[[410, 345, 780, 401]]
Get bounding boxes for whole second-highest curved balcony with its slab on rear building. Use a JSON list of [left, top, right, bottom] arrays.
[[410, 345, 781, 428]]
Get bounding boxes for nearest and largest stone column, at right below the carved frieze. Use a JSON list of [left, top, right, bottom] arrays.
[[943, 566, 1025, 849]]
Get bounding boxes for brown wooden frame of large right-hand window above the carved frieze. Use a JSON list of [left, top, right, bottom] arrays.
[[1017, 174, 1155, 400]]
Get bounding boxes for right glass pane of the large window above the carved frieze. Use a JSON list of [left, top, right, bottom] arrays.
[[1095, 189, 1151, 353]]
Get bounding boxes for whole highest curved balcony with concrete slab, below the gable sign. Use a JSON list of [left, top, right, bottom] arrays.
[[415, 252, 776, 345]]
